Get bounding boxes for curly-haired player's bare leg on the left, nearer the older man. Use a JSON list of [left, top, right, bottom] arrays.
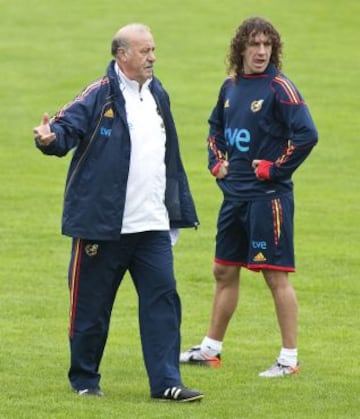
[[207, 263, 240, 342]]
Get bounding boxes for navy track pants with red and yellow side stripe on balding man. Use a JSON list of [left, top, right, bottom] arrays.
[[68, 231, 181, 395]]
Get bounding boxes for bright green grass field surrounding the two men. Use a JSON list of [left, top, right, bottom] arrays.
[[0, 0, 360, 419]]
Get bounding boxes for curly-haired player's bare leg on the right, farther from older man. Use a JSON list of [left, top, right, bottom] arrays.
[[263, 270, 298, 349]]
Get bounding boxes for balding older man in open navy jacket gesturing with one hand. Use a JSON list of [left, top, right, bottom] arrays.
[[34, 24, 203, 402]]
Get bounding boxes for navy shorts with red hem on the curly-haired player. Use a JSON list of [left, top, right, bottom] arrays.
[[215, 194, 295, 272]]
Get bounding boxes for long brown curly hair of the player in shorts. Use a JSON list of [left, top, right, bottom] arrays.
[[227, 17, 282, 79]]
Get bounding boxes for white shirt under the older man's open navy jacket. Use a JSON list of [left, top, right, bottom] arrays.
[[115, 65, 169, 234]]
